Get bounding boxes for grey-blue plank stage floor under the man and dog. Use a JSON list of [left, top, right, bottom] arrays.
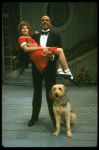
[[2, 84, 98, 147]]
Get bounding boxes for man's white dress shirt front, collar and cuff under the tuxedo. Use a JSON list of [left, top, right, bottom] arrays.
[[40, 29, 54, 60]]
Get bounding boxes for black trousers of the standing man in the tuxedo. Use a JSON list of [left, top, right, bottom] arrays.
[[32, 61, 56, 121]]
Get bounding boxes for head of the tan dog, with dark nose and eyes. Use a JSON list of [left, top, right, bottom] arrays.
[[51, 84, 67, 100]]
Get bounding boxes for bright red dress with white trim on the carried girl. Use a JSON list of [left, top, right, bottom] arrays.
[[18, 36, 57, 72]]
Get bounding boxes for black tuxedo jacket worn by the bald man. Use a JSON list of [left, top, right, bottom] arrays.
[[32, 31, 62, 76]]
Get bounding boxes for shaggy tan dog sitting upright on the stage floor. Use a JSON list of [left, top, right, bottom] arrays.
[[51, 84, 76, 137]]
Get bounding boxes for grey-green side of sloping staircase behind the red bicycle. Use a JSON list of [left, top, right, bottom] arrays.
[[68, 47, 98, 82]]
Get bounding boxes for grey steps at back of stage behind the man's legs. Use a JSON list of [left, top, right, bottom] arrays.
[[3, 68, 74, 86]]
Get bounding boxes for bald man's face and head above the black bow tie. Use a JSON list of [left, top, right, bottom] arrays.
[[40, 16, 51, 31]]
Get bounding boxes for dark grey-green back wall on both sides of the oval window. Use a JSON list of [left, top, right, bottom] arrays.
[[21, 2, 97, 50]]
